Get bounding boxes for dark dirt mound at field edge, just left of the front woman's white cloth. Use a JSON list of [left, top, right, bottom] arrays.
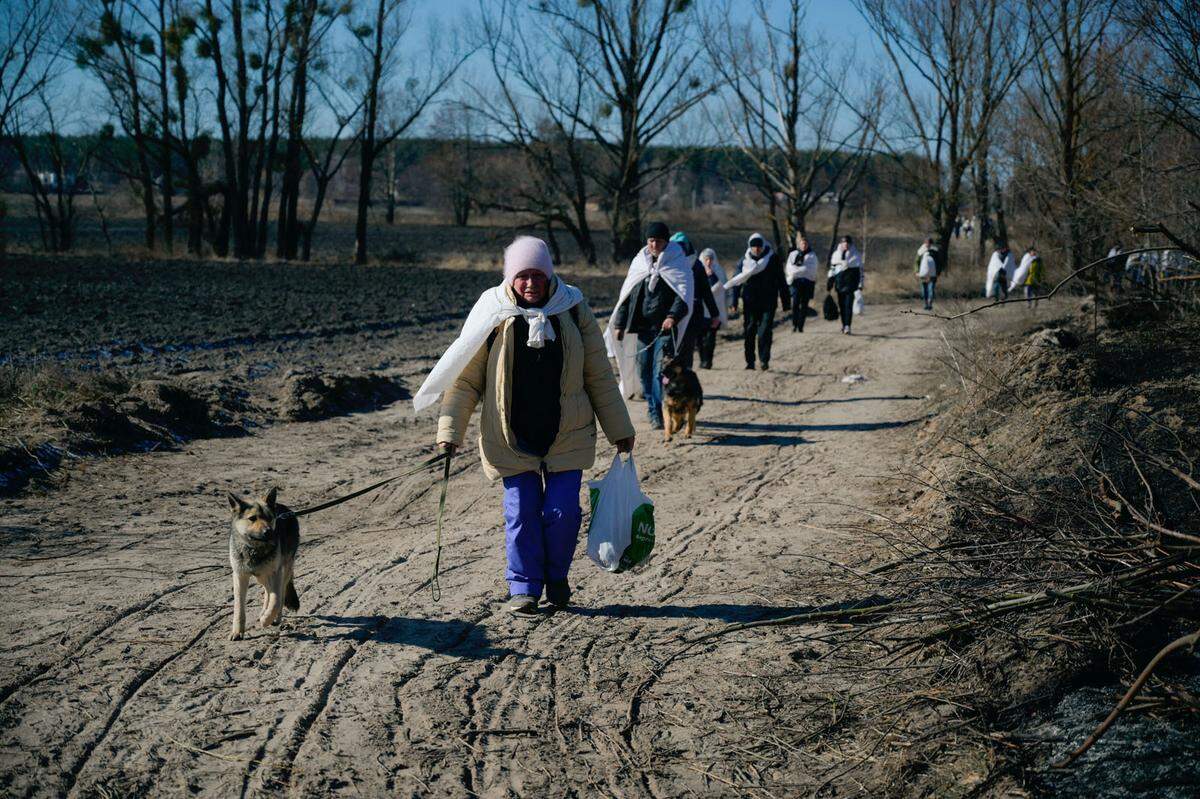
[[278, 372, 412, 421]]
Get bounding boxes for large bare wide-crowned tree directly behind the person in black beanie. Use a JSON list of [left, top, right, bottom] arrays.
[[522, 0, 713, 260]]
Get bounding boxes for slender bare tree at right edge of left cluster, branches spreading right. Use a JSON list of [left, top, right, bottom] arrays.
[[350, 0, 468, 264]]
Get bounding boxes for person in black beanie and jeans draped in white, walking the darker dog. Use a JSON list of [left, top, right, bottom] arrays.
[[605, 222, 696, 429]]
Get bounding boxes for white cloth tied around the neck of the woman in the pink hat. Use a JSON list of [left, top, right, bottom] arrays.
[[413, 278, 583, 413]]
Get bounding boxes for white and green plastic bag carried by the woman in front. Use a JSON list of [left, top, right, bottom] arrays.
[[588, 455, 654, 573]]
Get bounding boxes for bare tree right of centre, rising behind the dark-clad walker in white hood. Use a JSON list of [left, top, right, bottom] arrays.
[[707, 0, 877, 246]]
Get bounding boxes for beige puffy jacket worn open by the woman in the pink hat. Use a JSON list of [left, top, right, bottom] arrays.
[[438, 278, 634, 480]]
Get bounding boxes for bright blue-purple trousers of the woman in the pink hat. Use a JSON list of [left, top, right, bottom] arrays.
[[504, 469, 583, 596]]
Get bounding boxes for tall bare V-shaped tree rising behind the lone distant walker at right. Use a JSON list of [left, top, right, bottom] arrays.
[[854, 0, 1036, 266]]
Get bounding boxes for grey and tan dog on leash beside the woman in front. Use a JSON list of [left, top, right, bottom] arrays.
[[229, 488, 300, 641]]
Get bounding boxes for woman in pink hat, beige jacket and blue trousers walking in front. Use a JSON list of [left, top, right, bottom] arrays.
[[413, 236, 634, 614]]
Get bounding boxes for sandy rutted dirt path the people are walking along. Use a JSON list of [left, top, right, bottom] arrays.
[[0, 307, 935, 797]]
